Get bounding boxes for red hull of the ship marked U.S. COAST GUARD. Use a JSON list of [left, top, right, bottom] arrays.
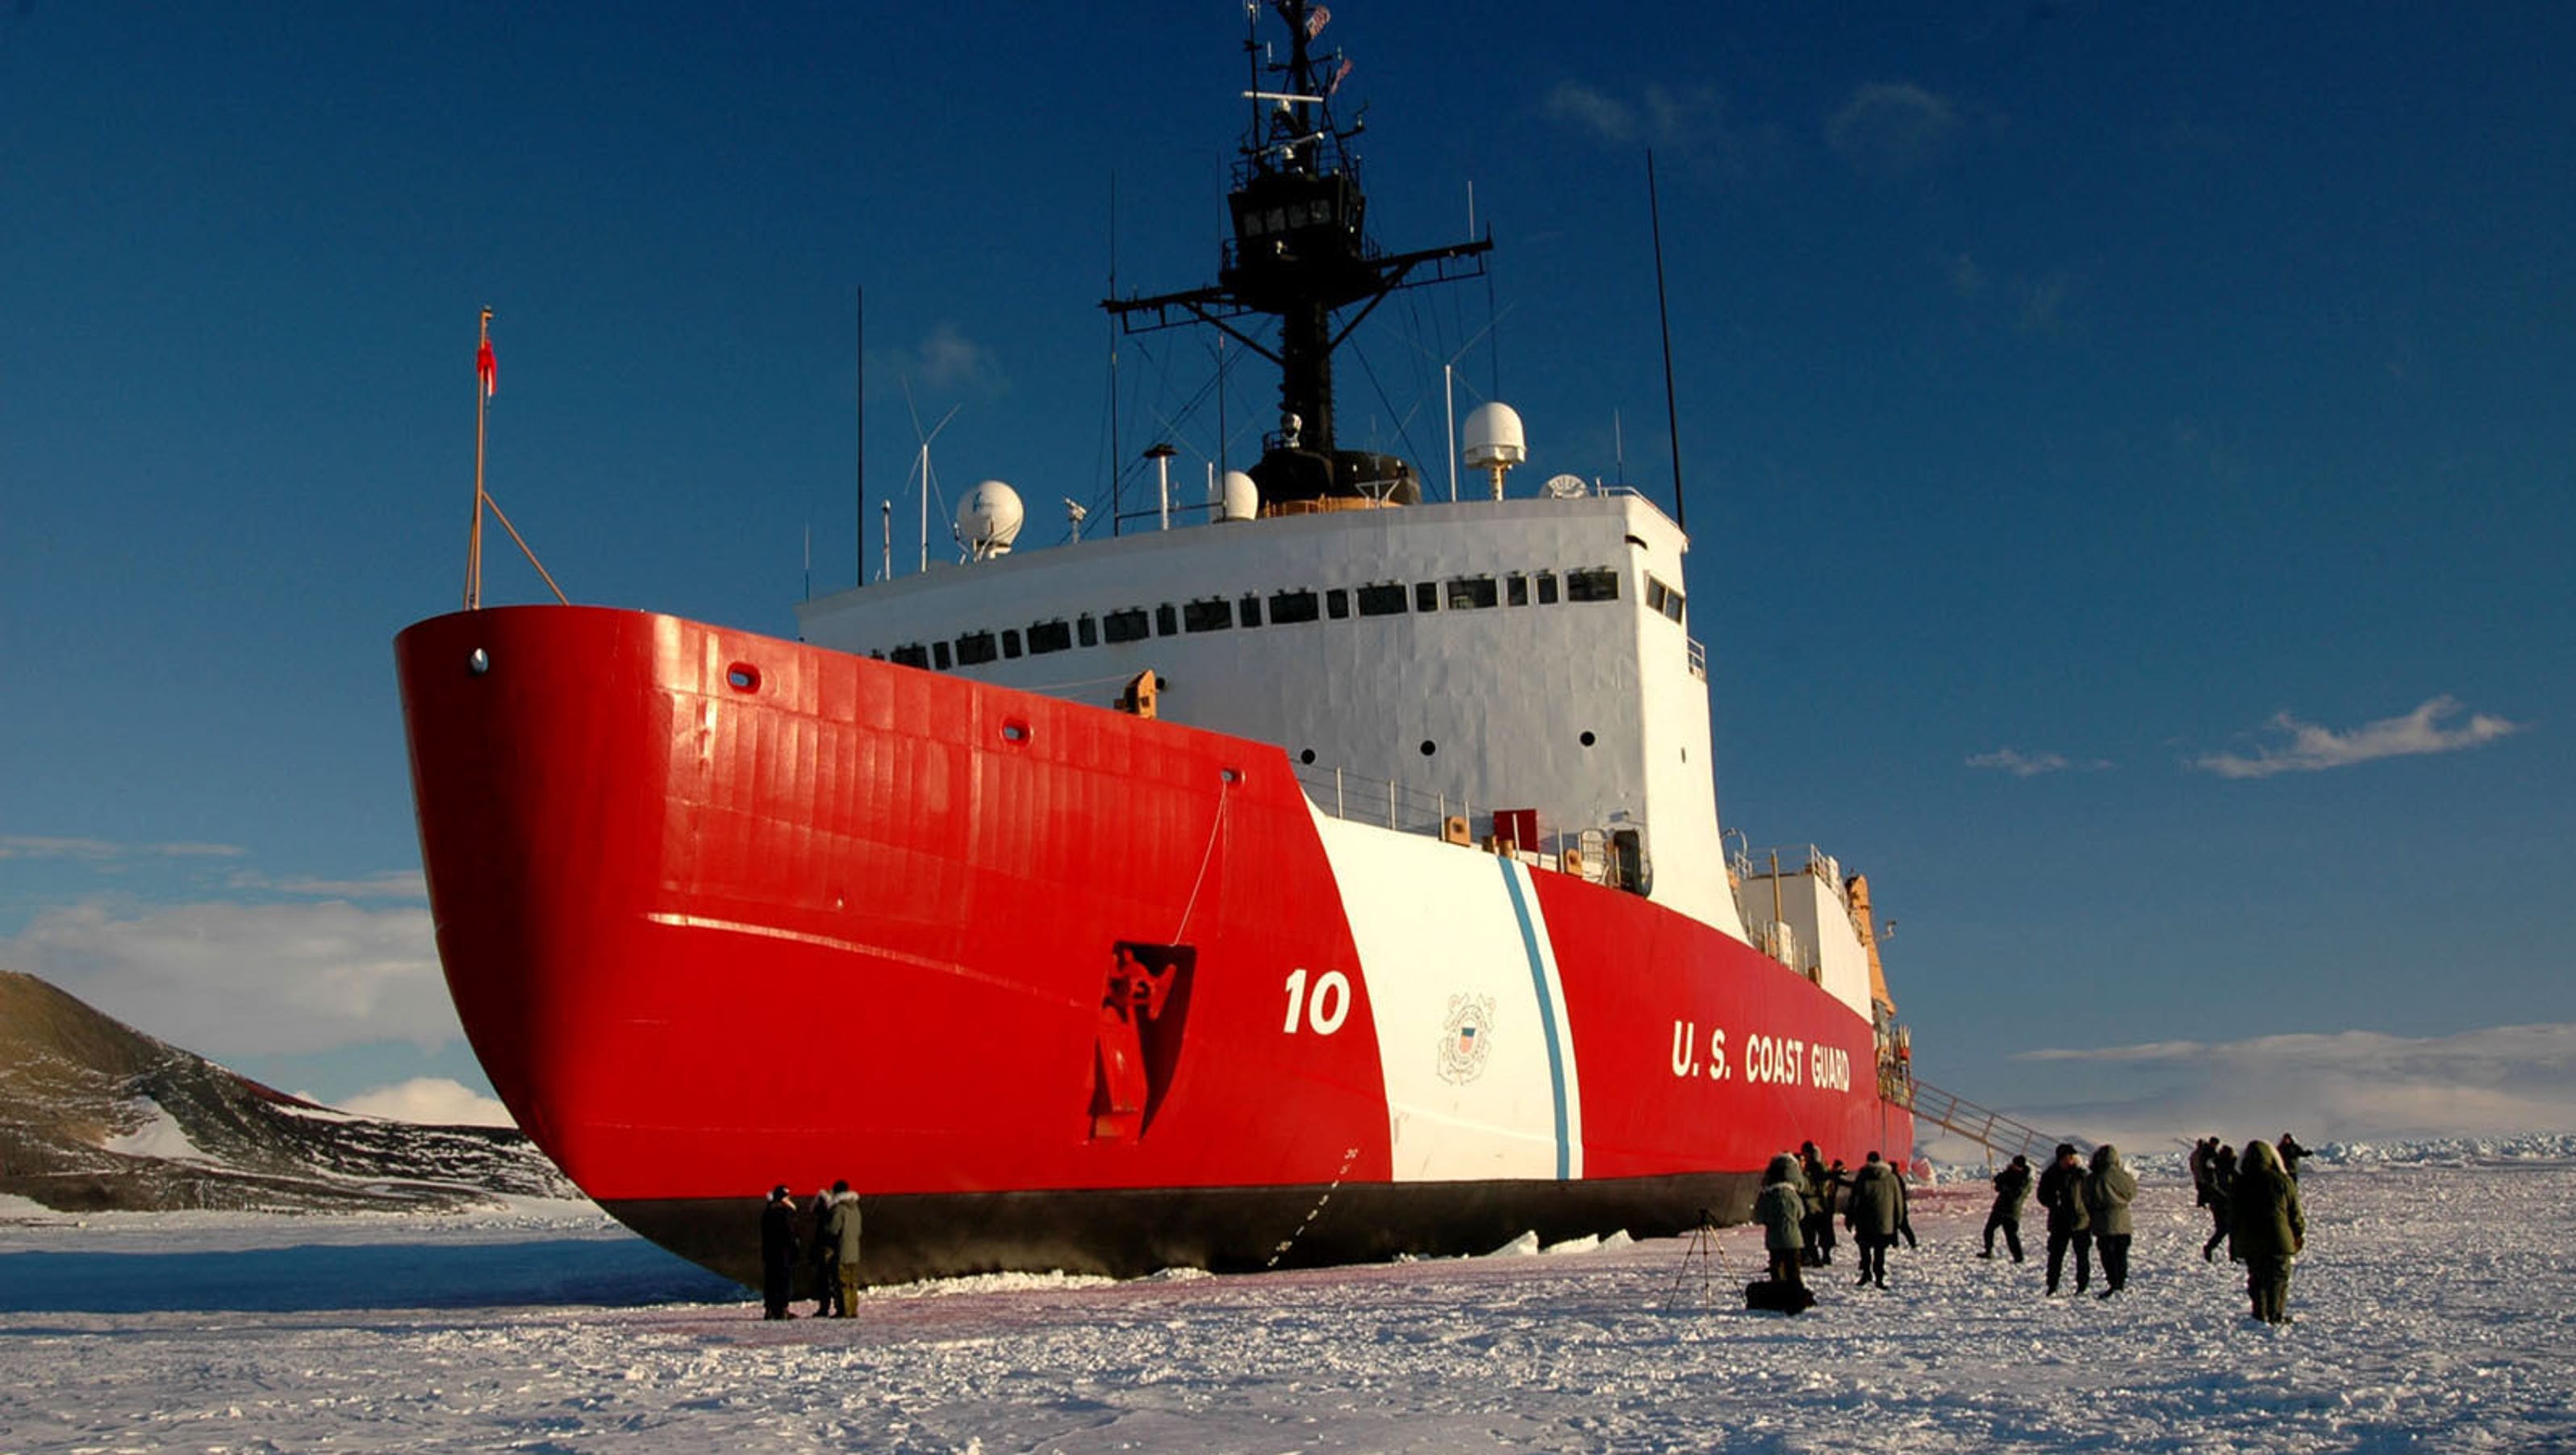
[[397, 608, 1911, 1282]]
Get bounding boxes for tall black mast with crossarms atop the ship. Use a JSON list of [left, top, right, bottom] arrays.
[[1100, 0, 1494, 512]]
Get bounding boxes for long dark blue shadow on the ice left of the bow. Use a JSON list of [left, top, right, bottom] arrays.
[[0, 1239, 747, 1313]]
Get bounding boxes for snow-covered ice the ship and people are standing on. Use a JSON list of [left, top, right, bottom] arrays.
[[0, 1144, 2576, 1455]]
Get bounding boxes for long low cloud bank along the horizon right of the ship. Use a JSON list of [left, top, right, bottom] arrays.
[[1978, 1025, 2576, 1151]]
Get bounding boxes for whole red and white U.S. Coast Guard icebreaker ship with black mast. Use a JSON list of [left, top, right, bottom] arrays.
[[395, 0, 1911, 1282]]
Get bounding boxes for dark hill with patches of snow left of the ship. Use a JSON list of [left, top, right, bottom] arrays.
[[0, 971, 579, 1213]]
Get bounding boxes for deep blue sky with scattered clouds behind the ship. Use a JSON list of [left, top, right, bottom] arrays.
[[0, 0, 2576, 1131]]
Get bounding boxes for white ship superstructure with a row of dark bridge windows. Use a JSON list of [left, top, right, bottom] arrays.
[[799, 489, 1744, 938]]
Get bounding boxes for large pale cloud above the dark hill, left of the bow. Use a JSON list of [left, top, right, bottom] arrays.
[[0, 901, 461, 1061]]
